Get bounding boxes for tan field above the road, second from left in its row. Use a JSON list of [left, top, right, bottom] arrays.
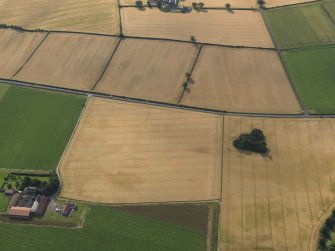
[[14, 33, 118, 90]]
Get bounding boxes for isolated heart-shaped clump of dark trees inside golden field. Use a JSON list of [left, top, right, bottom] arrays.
[[233, 129, 268, 154]]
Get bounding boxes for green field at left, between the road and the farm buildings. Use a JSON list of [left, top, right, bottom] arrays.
[[0, 86, 86, 170]]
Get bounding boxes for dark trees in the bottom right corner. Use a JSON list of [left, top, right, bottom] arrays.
[[318, 209, 335, 251]]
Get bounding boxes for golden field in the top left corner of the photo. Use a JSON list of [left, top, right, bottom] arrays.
[[0, 0, 120, 34]]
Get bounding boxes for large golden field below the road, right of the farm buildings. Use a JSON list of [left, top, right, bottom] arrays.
[[60, 98, 222, 203]]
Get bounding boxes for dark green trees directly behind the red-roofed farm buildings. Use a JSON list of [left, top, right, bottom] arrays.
[[5, 172, 60, 196]]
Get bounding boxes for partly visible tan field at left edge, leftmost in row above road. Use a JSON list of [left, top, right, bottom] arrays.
[[0, 30, 46, 78]]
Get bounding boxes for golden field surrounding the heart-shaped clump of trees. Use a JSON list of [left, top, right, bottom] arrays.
[[221, 117, 335, 250]]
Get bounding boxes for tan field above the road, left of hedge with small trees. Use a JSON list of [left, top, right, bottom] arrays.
[[95, 39, 197, 103]]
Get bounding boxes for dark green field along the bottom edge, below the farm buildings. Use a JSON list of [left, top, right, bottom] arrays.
[[0, 206, 206, 251]]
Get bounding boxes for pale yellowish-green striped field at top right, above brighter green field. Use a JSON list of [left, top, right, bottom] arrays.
[[264, 4, 335, 49]]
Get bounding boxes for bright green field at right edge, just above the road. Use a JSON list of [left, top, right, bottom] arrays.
[[283, 46, 335, 114]]
